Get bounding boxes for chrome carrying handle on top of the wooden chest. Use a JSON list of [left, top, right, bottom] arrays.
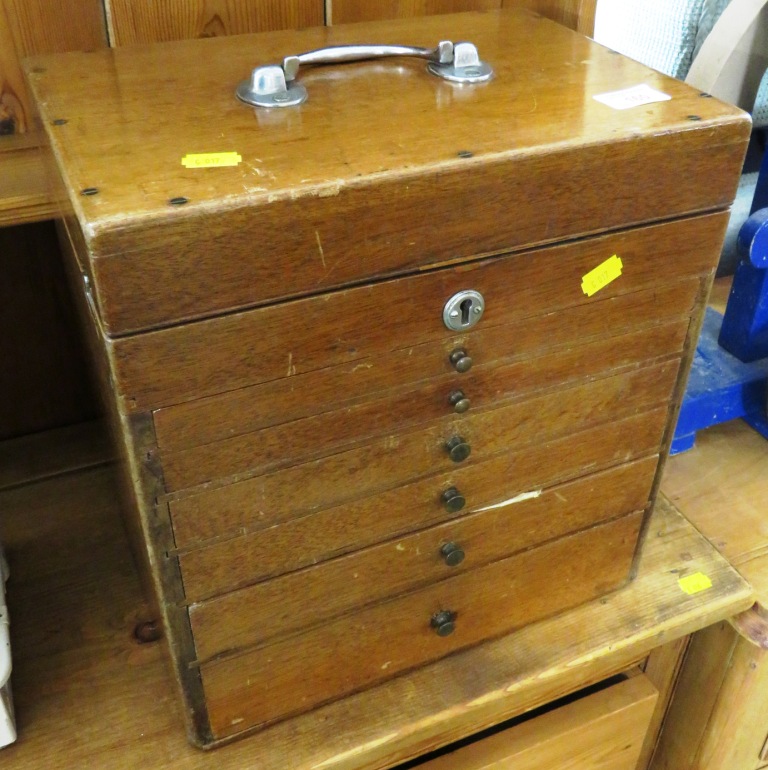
[[236, 40, 493, 107]]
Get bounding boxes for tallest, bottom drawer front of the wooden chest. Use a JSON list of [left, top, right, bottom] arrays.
[[201, 513, 644, 738]]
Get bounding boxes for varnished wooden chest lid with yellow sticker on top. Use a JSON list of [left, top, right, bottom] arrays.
[[27, 11, 750, 335]]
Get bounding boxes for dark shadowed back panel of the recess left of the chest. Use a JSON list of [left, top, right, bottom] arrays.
[[0, 222, 98, 440]]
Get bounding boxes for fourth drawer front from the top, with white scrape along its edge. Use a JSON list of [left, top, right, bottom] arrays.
[[179, 440, 658, 602]]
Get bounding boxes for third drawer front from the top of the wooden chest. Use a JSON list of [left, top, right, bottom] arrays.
[[170, 361, 679, 548]]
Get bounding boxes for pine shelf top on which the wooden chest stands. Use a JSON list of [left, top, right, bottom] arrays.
[[0, 468, 751, 770]]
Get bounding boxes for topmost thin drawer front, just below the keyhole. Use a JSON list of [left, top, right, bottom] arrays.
[[154, 279, 700, 452]]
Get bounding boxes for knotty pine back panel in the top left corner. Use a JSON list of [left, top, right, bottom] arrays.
[[0, 0, 107, 135]]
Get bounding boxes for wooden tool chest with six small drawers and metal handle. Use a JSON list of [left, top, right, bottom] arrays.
[[28, 6, 749, 745]]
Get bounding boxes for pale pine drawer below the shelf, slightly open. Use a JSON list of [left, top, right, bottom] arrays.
[[402, 672, 659, 770]]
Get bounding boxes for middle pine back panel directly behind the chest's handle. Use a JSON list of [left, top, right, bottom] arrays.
[[104, 0, 325, 46]]
